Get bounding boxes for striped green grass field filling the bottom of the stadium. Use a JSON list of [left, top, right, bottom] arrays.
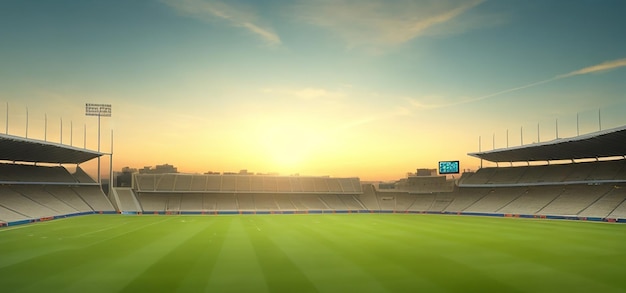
[[0, 214, 626, 292]]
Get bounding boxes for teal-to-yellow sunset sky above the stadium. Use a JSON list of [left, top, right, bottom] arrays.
[[0, 0, 626, 180]]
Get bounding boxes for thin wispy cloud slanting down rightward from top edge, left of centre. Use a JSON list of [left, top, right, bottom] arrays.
[[163, 0, 282, 46]]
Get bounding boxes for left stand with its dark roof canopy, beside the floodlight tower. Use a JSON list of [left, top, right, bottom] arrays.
[[0, 134, 115, 225]]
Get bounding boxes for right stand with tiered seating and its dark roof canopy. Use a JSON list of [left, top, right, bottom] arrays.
[[454, 126, 626, 218]]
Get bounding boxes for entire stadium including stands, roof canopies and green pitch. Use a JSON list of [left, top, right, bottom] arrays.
[[0, 110, 626, 292]]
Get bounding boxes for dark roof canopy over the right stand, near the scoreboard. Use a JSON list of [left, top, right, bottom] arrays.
[[468, 126, 626, 162]]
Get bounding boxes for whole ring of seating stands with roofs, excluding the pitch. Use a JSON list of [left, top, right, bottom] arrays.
[[0, 118, 626, 223]]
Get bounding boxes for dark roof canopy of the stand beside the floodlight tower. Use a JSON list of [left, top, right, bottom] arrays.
[[0, 134, 103, 164]]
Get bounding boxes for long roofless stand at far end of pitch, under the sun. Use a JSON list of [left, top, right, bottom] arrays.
[[128, 173, 360, 213]]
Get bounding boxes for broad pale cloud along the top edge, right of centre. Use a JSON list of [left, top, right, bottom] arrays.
[[295, 0, 483, 48]]
